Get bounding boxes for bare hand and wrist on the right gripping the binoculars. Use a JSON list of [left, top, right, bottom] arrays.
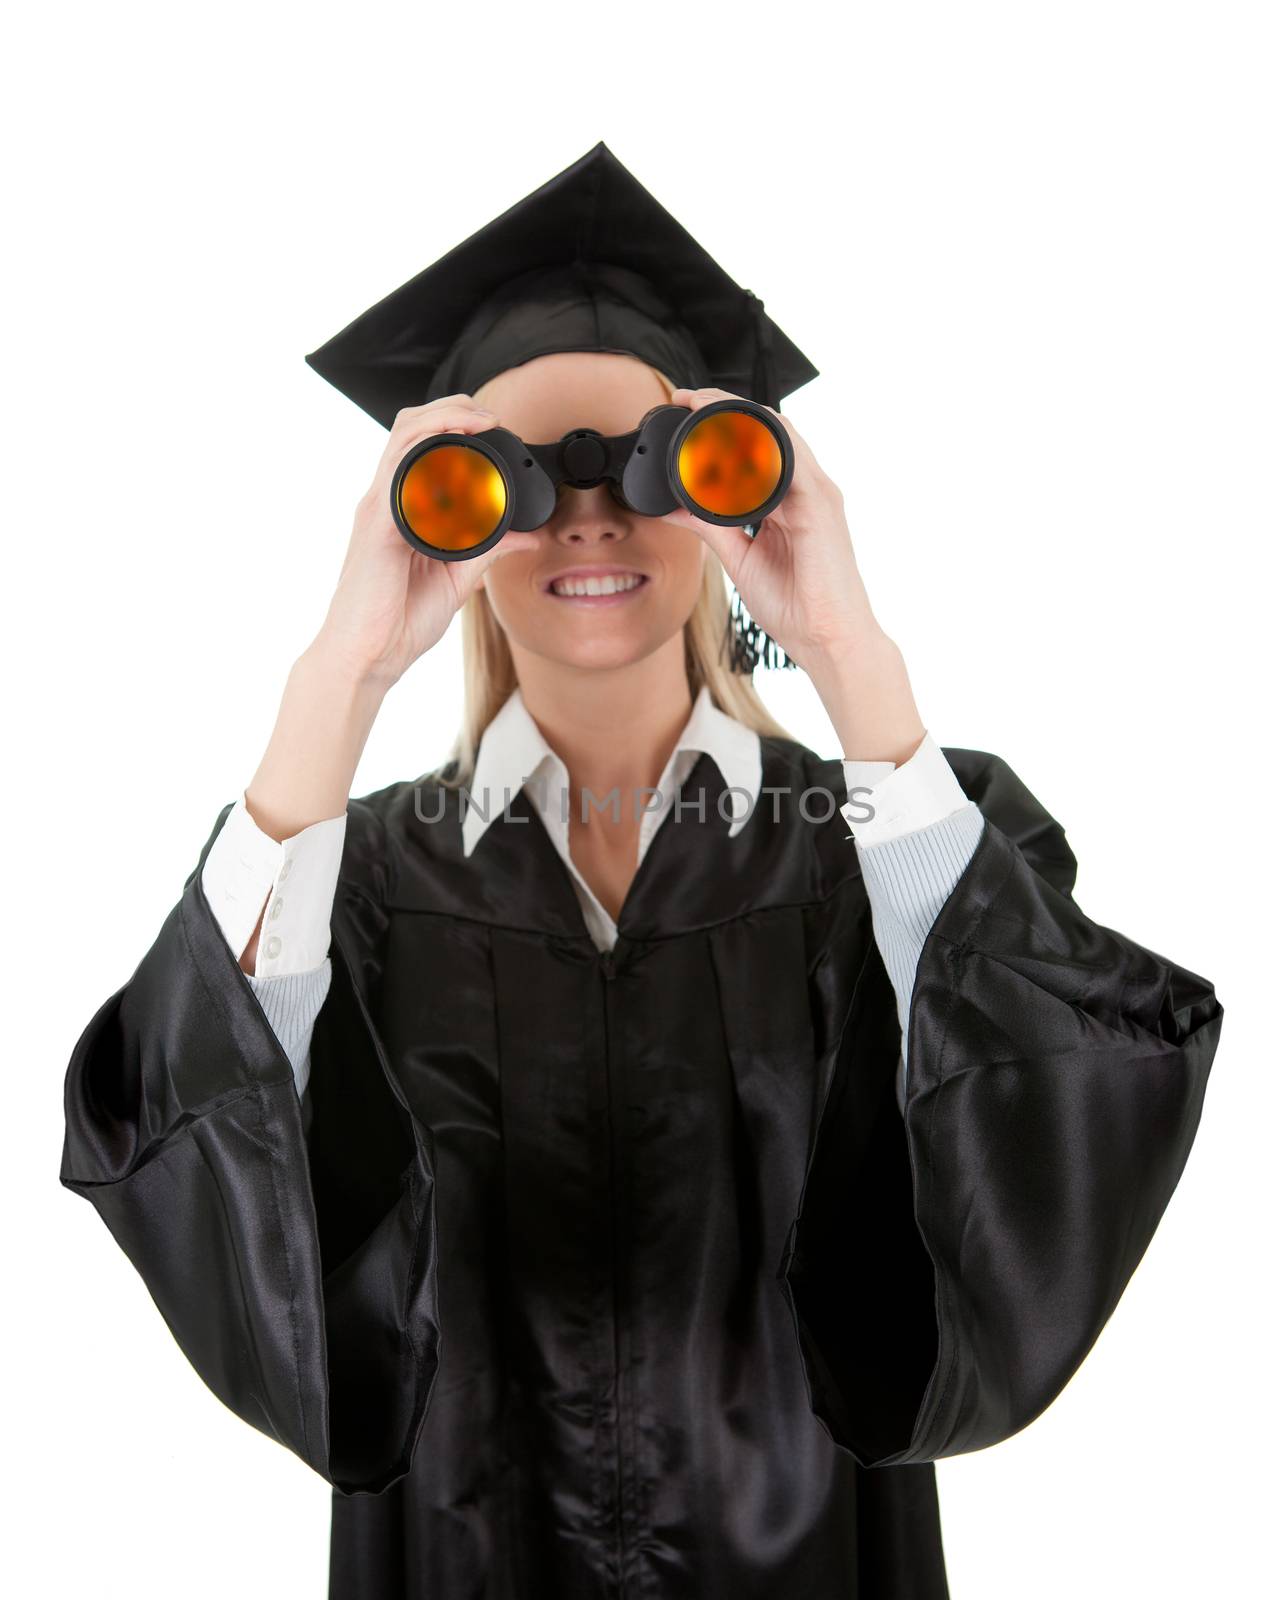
[[664, 389, 924, 763]]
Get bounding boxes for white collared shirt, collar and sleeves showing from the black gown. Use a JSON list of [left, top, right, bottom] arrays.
[[200, 685, 982, 1104]]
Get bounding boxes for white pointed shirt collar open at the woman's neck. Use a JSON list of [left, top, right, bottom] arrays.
[[462, 683, 761, 856]]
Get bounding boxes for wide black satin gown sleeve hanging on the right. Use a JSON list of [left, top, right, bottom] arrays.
[[779, 750, 1222, 1467]]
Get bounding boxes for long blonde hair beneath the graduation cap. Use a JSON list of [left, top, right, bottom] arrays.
[[435, 363, 792, 786]]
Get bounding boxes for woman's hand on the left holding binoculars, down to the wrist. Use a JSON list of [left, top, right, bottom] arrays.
[[312, 394, 539, 688]]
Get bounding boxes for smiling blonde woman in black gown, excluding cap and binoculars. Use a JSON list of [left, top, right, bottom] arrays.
[[62, 144, 1222, 1600]]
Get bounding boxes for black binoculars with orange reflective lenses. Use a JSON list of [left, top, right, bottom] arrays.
[[392, 400, 796, 562]]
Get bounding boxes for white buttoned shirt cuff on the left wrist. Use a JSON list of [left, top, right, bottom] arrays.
[[200, 794, 347, 978]]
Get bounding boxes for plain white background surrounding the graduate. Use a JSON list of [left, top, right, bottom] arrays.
[[0, 0, 1281, 1600]]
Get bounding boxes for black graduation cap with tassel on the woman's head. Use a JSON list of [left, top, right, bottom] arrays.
[[307, 131, 819, 672]]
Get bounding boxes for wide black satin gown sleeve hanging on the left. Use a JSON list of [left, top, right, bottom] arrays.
[[61, 802, 438, 1494]]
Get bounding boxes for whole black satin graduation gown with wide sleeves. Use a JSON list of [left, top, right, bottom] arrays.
[[61, 738, 1222, 1600]]
